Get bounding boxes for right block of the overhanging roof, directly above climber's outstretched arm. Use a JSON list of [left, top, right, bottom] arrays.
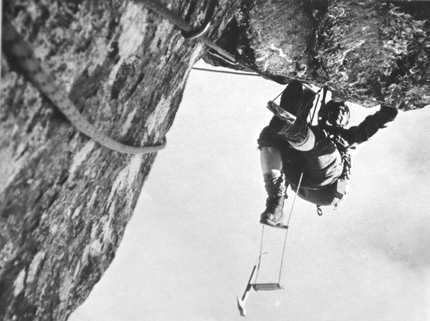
[[317, 1, 430, 110]]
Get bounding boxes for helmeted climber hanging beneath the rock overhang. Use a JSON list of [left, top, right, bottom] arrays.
[[258, 80, 398, 227]]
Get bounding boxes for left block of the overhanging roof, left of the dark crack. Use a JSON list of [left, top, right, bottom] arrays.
[[204, 0, 320, 79]]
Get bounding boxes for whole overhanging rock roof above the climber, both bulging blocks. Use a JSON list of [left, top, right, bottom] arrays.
[[205, 0, 430, 110]]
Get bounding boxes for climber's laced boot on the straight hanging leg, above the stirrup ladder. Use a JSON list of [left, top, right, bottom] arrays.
[[260, 171, 286, 228]]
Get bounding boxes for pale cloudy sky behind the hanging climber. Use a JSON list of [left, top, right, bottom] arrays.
[[69, 60, 430, 321]]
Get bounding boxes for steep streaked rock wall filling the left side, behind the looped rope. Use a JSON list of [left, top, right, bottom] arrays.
[[0, 0, 237, 320]]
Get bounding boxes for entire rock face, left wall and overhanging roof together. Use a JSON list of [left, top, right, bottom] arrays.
[[0, 0, 430, 320]]
